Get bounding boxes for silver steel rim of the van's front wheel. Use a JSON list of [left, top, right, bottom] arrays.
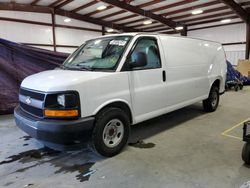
[[102, 119, 124, 148]]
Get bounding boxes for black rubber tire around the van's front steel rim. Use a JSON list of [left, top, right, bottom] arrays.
[[92, 107, 130, 157]]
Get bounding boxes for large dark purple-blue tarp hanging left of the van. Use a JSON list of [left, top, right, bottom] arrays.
[[0, 38, 69, 114]]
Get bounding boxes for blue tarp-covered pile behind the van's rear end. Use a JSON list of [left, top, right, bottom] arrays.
[[227, 61, 250, 85]]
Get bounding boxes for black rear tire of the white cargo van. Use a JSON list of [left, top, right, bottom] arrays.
[[203, 86, 220, 112]]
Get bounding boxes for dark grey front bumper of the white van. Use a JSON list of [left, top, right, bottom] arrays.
[[14, 106, 95, 145]]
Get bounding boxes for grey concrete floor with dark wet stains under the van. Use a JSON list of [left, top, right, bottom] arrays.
[[0, 88, 250, 188]]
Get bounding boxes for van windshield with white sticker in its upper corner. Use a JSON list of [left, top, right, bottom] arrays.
[[63, 36, 131, 71]]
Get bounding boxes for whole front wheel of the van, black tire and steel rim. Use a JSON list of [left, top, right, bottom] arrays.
[[92, 108, 130, 157]]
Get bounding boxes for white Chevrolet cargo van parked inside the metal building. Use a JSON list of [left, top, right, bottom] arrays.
[[15, 33, 227, 156]]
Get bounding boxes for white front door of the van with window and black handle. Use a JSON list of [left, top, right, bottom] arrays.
[[127, 37, 167, 122]]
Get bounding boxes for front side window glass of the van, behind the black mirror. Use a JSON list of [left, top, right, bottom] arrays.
[[130, 38, 161, 70]]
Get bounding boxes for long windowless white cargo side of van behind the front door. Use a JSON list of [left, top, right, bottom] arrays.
[[160, 35, 226, 111]]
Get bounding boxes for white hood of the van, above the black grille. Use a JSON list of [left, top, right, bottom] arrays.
[[21, 70, 111, 92]]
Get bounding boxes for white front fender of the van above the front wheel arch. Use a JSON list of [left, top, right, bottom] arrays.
[[78, 72, 133, 116]]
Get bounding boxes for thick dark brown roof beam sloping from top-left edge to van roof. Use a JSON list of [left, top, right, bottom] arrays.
[[0, 3, 141, 32]]
